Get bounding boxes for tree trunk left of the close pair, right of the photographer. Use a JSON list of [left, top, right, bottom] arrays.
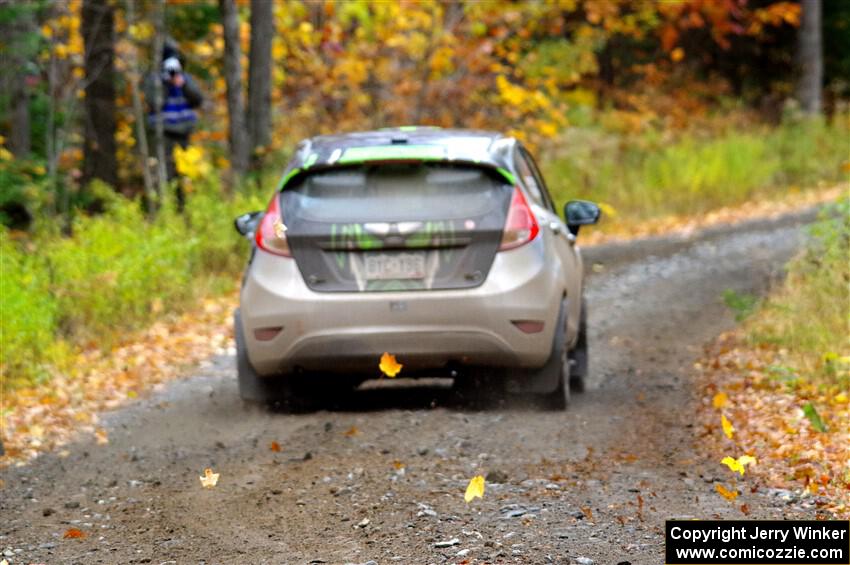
[[218, 0, 249, 176]]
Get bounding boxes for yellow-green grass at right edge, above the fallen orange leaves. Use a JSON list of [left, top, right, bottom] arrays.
[[745, 198, 850, 387]]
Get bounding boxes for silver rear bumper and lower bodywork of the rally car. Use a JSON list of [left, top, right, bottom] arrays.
[[241, 240, 564, 375]]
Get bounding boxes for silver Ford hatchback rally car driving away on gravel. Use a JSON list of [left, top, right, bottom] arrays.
[[234, 127, 599, 409]]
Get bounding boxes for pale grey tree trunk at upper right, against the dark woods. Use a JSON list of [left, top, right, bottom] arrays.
[[797, 0, 823, 114]]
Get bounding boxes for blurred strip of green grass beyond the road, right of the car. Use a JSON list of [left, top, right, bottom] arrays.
[[544, 116, 850, 218]]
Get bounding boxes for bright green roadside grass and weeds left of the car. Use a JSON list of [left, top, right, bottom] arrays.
[[0, 178, 268, 388]]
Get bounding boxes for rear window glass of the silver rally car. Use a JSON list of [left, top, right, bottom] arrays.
[[283, 163, 510, 222]]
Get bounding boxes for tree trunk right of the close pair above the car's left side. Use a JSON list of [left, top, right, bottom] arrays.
[[248, 0, 274, 160]]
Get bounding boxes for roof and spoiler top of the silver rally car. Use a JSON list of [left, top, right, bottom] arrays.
[[280, 126, 516, 188]]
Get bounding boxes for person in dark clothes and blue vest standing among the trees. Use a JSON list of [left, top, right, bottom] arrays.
[[145, 46, 203, 212]]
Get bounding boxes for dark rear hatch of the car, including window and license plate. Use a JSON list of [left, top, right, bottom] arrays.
[[280, 162, 513, 292]]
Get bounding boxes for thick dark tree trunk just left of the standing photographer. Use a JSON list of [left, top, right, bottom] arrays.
[[82, 0, 118, 187]]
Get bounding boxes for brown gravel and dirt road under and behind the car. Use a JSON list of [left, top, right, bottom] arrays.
[[0, 209, 814, 565]]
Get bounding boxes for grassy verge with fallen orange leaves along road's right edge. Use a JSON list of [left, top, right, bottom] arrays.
[[703, 200, 850, 516]]
